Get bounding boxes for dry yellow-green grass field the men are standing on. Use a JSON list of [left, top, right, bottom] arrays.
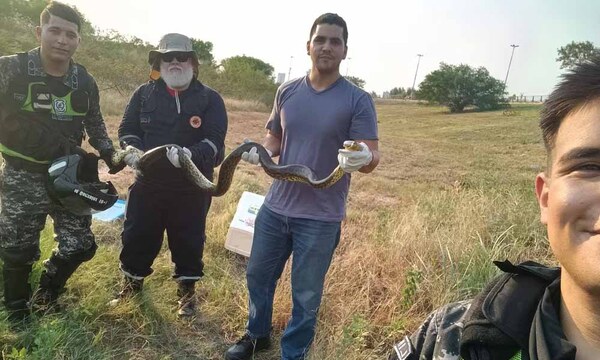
[[0, 101, 552, 360]]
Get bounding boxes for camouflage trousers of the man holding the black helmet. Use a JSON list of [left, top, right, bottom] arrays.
[[0, 163, 95, 264]]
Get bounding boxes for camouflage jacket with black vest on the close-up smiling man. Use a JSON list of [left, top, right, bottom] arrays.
[[390, 261, 569, 360]]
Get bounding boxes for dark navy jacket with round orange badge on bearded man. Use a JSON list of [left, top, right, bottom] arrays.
[[119, 79, 227, 190]]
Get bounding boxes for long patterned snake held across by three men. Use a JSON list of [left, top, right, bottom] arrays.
[[112, 142, 360, 196]]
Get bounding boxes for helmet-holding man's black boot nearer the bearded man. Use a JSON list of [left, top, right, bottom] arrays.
[[29, 254, 81, 313]]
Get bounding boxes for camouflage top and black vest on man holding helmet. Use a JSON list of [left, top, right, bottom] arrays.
[[0, 48, 112, 172]]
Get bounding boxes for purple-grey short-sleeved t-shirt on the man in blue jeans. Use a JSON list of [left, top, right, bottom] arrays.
[[265, 76, 378, 222]]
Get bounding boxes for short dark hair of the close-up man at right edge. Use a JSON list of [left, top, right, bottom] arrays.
[[540, 57, 600, 155]]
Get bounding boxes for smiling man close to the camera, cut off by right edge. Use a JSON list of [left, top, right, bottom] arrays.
[[390, 58, 600, 360]]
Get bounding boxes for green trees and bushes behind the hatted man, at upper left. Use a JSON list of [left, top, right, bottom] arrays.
[[0, 0, 277, 106]]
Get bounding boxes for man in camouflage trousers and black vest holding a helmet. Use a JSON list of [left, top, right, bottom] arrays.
[[0, 2, 122, 317]]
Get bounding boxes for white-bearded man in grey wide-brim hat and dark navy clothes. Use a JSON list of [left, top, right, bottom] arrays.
[[111, 33, 227, 316]]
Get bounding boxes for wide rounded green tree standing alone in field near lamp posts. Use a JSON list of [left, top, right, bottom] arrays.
[[418, 63, 504, 112]]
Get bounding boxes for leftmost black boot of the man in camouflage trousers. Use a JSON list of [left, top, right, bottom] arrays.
[[2, 263, 31, 321]]
